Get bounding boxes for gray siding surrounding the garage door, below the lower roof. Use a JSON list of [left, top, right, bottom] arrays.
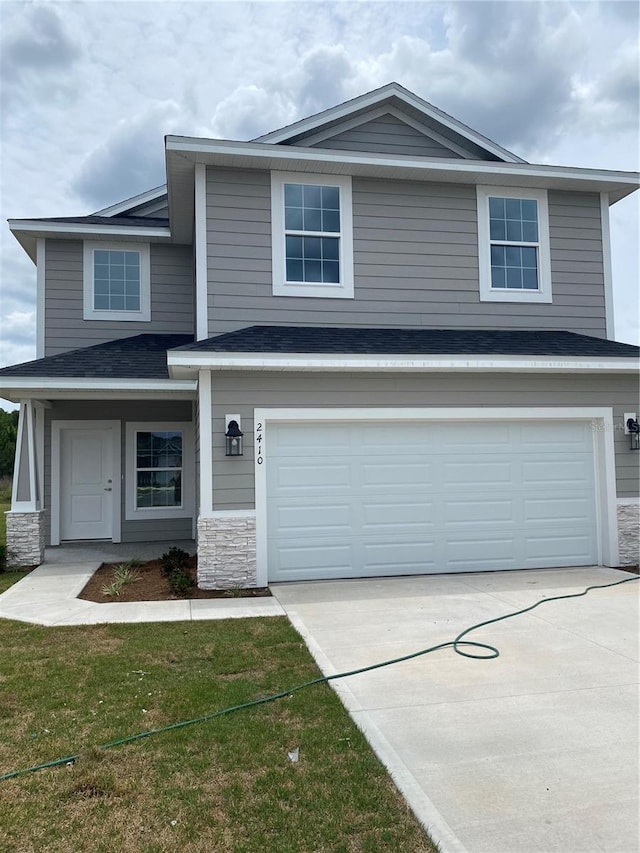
[[208, 372, 640, 510]]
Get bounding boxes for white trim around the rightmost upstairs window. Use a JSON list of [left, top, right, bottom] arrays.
[[476, 186, 553, 303]]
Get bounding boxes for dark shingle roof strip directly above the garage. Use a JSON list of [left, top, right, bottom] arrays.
[[174, 326, 640, 358]]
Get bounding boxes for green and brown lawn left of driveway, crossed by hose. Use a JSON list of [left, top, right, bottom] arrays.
[[0, 618, 435, 853]]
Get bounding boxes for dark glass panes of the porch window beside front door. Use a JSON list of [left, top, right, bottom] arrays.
[[136, 431, 182, 509]]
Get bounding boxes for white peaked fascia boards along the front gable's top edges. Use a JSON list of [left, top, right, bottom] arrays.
[[252, 83, 524, 163]]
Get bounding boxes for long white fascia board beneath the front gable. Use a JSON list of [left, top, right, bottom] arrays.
[[166, 141, 640, 198]]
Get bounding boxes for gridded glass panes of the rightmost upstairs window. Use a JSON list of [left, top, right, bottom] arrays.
[[489, 196, 540, 290]]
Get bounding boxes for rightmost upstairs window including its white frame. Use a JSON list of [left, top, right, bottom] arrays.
[[477, 187, 551, 302]]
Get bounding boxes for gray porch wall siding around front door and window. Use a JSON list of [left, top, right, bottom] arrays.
[[44, 400, 192, 543]]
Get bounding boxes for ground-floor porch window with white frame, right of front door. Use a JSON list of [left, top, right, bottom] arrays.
[[126, 423, 194, 520]]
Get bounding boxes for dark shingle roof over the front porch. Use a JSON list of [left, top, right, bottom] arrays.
[[0, 335, 193, 380]]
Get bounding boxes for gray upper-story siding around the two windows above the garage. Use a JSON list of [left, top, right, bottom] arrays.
[[207, 169, 606, 337]]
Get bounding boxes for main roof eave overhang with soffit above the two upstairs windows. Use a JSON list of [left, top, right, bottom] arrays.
[[165, 136, 640, 242]]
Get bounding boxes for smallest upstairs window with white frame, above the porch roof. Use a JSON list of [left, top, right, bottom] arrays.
[[84, 243, 151, 321]]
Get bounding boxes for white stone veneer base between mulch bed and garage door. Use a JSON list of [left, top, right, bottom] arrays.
[[198, 510, 257, 589]]
